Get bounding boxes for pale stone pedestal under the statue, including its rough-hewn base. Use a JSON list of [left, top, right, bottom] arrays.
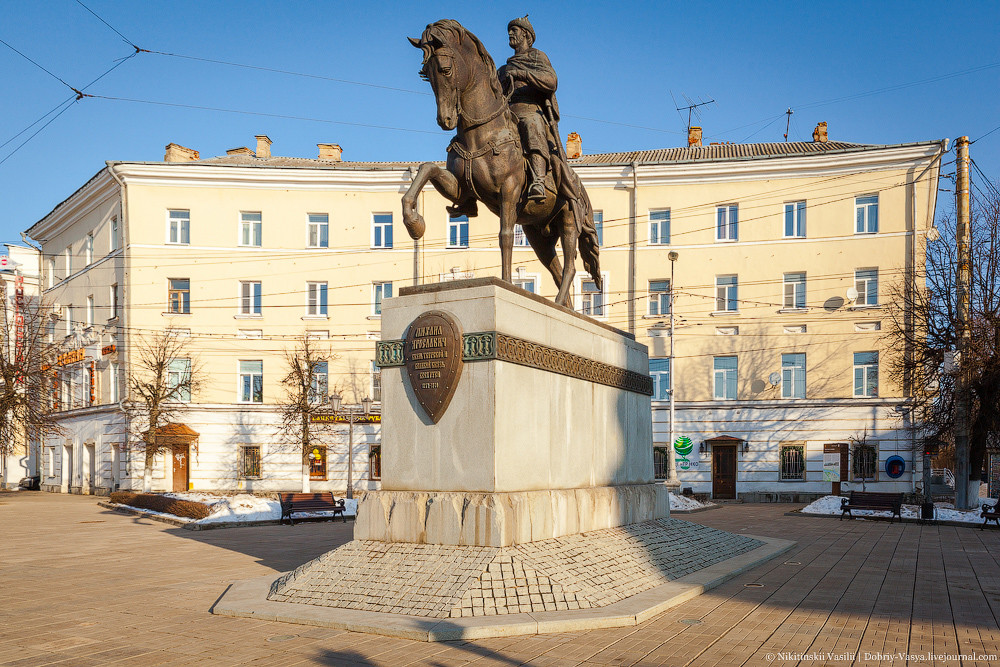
[[355, 278, 669, 546]]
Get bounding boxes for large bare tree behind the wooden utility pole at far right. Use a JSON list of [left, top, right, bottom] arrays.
[[886, 184, 1000, 507]]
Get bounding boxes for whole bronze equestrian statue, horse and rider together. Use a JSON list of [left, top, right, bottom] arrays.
[[403, 17, 601, 306]]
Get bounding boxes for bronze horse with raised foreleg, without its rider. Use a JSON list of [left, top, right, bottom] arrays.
[[403, 19, 601, 306]]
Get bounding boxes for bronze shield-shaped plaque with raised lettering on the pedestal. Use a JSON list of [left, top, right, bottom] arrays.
[[403, 310, 462, 424]]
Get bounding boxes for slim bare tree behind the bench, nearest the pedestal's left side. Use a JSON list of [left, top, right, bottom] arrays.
[[280, 334, 334, 492]]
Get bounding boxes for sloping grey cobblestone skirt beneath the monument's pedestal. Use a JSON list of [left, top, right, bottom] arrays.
[[268, 519, 763, 618]]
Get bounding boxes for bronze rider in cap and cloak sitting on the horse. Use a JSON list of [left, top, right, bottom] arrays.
[[497, 16, 559, 201]]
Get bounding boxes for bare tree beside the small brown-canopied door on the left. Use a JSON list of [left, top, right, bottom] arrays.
[[123, 329, 202, 492]]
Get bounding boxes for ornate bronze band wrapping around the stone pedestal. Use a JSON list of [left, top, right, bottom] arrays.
[[375, 331, 653, 396]]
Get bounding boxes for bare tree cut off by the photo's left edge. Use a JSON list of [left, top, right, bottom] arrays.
[[0, 290, 62, 480]]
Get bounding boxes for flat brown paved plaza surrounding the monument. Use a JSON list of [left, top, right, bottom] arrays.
[[0, 492, 1000, 667]]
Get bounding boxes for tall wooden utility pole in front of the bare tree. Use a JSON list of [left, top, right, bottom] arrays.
[[955, 137, 972, 510]]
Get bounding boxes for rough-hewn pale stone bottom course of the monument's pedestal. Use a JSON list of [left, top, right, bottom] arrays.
[[354, 484, 670, 547]]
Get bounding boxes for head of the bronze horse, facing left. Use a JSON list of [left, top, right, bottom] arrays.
[[407, 19, 488, 130]]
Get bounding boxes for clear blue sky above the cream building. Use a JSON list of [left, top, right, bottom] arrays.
[[0, 0, 1000, 242]]
